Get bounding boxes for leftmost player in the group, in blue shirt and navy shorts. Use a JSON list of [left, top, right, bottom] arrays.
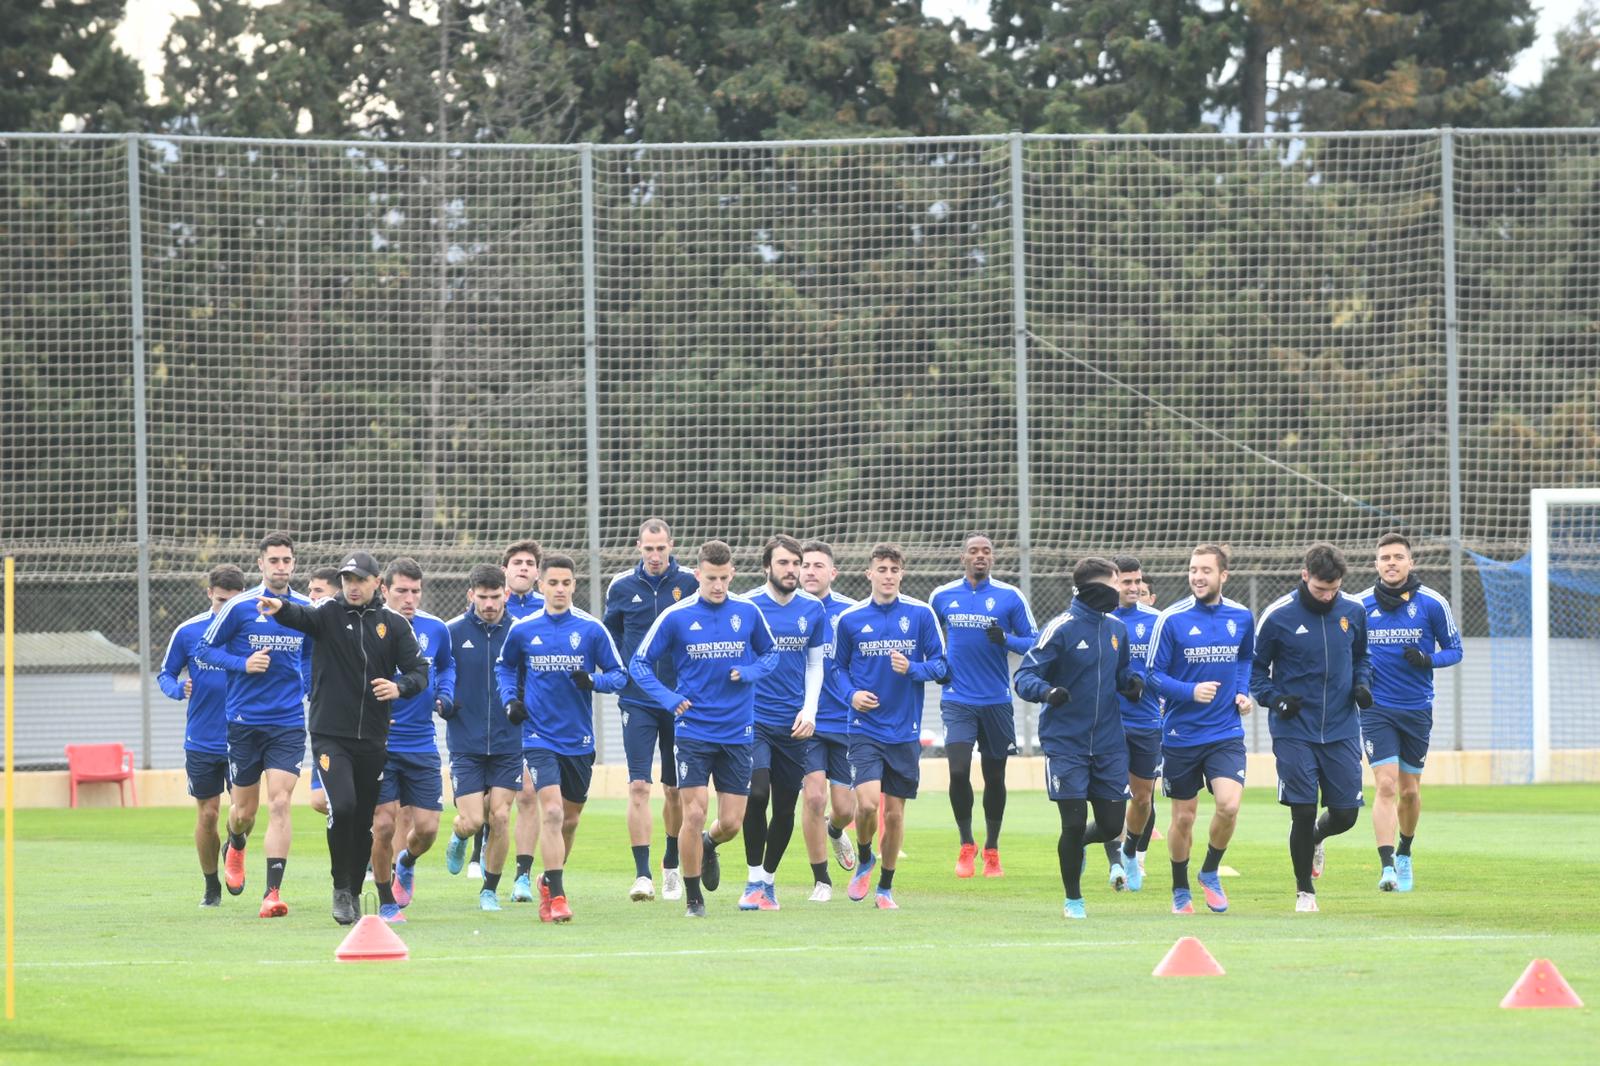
[[155, 563, 245, 908]]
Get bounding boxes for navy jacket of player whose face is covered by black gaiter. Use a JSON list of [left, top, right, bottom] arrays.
[[1011, 597, 1133, 755]]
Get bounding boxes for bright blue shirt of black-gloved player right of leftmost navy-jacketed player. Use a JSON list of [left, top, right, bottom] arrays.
[[494, 607, 627, 755]]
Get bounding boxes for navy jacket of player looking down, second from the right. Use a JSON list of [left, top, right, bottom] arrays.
[[1250, 589, 1371, 744]]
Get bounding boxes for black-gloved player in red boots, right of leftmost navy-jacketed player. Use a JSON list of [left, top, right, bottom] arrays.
[[494, 555, 627, 922]]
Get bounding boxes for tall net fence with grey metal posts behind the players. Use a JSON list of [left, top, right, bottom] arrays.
[[0, 131, 1600, 762]]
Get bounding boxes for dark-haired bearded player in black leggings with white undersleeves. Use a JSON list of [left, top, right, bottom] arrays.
[[739, 533, 829, 911]]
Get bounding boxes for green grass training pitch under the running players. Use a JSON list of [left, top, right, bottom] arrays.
[[0, 786, 1600, 1066]]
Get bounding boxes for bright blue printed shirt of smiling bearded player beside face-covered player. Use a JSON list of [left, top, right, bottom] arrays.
[[1144, 595, 1256, 747]]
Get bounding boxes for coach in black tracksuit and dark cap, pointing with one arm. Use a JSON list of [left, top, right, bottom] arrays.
[[261, 552, 427, 925]]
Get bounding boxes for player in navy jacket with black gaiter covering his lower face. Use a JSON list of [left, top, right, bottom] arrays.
[[1013, 555, 1144, 919]]
